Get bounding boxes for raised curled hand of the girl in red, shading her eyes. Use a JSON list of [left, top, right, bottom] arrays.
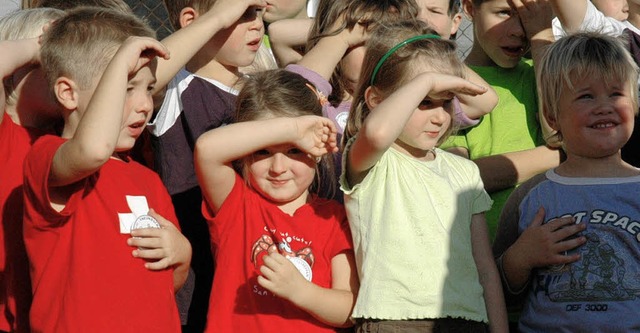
[[294, 116, 338, 157]]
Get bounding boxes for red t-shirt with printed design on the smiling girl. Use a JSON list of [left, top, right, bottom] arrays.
[[202, 175, 353, 333]]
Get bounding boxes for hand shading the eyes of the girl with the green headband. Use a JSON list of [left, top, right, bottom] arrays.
[[420, 72, 487, 99]]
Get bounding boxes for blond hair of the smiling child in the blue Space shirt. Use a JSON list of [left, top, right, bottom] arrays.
[[536, 32, 639, 141]]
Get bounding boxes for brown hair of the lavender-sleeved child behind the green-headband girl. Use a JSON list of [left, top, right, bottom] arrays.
[[306, 0, 420, 105]]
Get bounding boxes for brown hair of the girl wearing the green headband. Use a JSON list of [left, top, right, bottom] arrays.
[[342, 20, 465, 146]]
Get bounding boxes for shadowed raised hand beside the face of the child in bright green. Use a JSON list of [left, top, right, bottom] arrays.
[[507, 0, 553, 40]]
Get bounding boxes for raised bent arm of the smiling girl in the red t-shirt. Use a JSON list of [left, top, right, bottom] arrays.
[[194, 116, 337, 212]]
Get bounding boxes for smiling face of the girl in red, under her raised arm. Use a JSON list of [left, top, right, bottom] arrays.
[[245, 144, 316, 210]]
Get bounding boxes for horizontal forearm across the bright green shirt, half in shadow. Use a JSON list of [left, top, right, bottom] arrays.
[[474, 146, 560, 193]]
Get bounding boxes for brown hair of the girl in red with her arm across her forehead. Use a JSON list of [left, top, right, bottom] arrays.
[[235, 69, 336, 198]]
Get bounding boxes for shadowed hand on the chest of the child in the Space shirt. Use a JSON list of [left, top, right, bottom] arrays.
[[512, 208, 586, 269]]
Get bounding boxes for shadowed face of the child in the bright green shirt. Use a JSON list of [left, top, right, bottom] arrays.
[[463, 0, 529, 68]]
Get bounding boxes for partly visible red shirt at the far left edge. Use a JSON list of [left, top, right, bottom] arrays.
[[0, 113, 43, 332]]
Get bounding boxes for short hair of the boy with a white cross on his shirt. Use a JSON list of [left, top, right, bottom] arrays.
[[41, 7, 155, 88]]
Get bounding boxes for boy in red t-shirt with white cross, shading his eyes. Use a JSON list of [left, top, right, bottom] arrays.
[[24, 7, 191, 332]]
